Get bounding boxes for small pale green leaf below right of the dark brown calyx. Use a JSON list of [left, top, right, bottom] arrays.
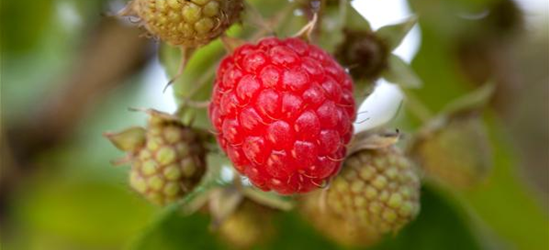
[[382, 55, 423, 88]]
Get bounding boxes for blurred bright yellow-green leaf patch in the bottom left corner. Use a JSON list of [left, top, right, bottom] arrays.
[[6, 177, 152, 249]]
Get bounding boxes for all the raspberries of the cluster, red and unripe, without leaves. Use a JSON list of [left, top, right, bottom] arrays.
[[108, 0, 490, 248]]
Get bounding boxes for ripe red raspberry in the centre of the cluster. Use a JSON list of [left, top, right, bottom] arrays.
[[209, 38, 355, 194]]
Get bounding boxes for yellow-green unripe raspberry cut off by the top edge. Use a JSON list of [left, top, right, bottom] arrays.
[[127, 0, 243, 48]]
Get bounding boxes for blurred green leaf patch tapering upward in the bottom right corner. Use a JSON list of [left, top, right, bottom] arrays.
[[459, 117, 549, 249]]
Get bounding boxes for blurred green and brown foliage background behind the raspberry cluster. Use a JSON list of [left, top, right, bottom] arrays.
[[0, 0, 549, 249]]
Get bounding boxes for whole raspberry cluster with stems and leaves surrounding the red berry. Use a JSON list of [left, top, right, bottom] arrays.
[[96, 0, 532, 249]]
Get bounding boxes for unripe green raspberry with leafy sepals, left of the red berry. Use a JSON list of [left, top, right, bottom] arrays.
[[109, 111, 206, 205]]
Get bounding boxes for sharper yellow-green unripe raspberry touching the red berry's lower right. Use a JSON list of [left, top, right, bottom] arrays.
[[326, 147, 420, 234]]
